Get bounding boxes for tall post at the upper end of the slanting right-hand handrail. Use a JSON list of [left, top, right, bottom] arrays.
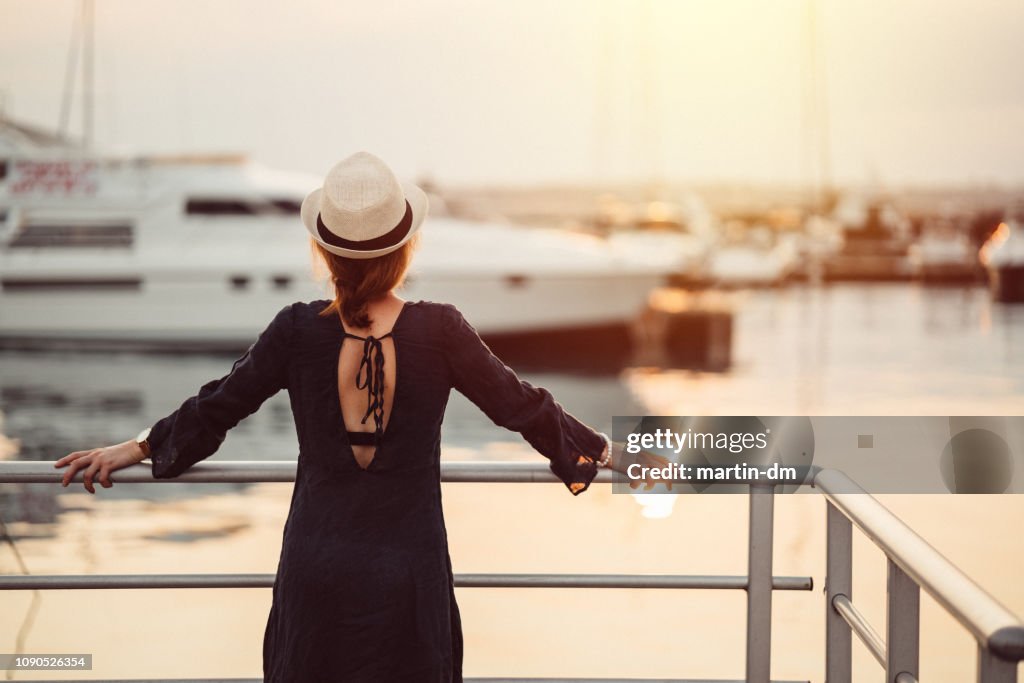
[[825, 502, 853, 683]]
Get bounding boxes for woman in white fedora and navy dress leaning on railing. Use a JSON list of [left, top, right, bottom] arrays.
[[55, 153, 659, 683]]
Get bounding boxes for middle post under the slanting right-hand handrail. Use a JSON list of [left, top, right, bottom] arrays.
[[886, 559, 921, 683]]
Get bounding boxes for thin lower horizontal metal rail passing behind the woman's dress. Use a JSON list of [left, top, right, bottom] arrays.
[[0, 573, 814, 591]]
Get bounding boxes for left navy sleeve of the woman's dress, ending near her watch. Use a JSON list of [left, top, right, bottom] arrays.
[[148, 304, 293, 479]]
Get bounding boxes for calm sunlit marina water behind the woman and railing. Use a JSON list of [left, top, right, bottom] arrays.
[[0, 284, 1024, 683]]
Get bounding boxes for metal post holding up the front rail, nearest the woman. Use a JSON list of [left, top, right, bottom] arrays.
[[746, 483, 775, 683]]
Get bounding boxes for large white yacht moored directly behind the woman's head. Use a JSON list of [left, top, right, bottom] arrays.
[[0, 119, 666, 348]]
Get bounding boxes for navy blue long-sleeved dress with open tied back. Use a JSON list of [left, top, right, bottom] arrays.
[[150, 300, 604, 683]]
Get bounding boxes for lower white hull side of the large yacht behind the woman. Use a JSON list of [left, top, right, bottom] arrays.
[[0, 266, 660, 350]]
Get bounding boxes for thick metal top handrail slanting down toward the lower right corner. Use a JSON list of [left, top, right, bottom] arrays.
[[814, 470, 1024, 661]]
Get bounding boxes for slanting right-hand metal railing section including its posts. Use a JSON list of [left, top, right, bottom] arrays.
[[814, 470, 1024, 683]]
